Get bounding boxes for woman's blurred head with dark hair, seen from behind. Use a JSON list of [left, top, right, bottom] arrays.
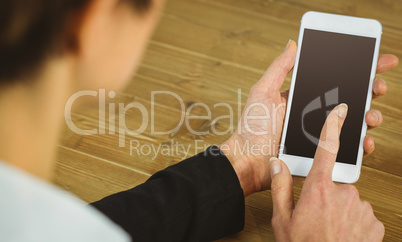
[[0, 0, 163, 89]]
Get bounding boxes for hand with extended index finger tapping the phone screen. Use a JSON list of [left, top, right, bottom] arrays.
[[270, 105, 384, 241]]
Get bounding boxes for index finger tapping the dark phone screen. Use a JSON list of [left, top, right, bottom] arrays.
[[307, 104, 348, 181]]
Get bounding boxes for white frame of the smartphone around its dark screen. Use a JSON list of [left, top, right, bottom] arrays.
[[279, 11, 382, 183]]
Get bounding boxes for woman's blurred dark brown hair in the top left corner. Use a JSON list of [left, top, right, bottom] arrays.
[[0, 0, 151, 86]]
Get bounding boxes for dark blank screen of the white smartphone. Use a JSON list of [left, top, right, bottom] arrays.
[[284, 29, 376, 164]]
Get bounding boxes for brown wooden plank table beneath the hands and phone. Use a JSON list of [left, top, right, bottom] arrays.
[[54, 0, 402, 241]]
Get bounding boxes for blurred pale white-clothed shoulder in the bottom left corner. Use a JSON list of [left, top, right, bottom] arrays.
[[0, 161, 130, 241]]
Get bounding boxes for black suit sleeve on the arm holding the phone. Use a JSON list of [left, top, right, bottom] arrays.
[[92, 146, 244, 241]]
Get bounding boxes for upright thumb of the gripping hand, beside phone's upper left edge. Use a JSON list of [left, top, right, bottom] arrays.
[[256, 40, 297, 92]]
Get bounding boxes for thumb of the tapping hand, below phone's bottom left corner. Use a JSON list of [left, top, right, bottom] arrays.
[[269, 157, 294, 223]]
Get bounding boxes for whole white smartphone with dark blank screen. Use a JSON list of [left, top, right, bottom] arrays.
[[279, 12, 382, 183]]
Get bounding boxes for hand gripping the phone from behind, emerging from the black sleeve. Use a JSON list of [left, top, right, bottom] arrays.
[[220, 36, 398, 196]]
